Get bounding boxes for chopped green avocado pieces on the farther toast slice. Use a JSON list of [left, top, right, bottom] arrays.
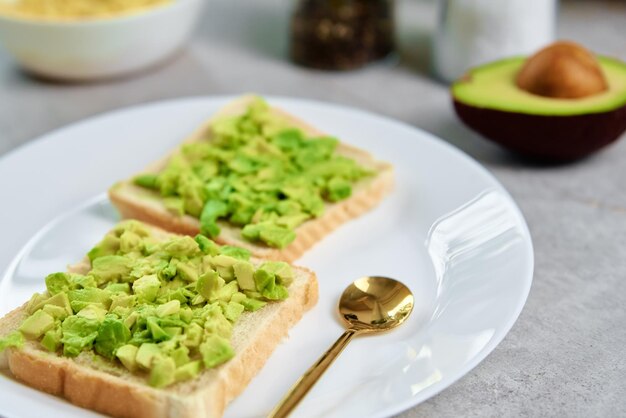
[[129, 98, 372, 248]]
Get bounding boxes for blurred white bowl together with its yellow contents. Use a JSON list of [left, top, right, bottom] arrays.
[[0, 0, 205, 81]]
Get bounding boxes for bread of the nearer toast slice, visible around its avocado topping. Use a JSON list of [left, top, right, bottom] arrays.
[[0, 224, 318, 418]]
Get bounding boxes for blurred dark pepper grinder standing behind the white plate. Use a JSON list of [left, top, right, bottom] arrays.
[[290, 0, 394, 70]]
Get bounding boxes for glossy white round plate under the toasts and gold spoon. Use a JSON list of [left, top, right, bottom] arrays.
[[0, 98, 533, 418]]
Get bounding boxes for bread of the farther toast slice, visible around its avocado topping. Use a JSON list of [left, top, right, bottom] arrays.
[[109, 96, 394, 262]]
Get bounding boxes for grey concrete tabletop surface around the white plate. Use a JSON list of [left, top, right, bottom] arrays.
[[0, 0, 626, 418]]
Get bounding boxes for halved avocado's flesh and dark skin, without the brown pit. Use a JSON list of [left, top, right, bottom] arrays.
[[452, 57, 626, 161]]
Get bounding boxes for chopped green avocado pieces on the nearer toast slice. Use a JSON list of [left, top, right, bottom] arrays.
[[0, 221, 294, 388]]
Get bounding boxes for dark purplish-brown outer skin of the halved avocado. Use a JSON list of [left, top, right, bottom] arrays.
[[453, 99, 626, 162]]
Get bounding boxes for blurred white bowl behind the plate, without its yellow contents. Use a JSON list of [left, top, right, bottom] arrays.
[[0, 0, 205, 80]]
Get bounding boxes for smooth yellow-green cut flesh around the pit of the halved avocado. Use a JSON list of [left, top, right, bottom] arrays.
[[452, 57, 626, 116]]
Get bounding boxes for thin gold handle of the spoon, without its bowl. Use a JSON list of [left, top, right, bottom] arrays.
[[268, 329, 357, 418]]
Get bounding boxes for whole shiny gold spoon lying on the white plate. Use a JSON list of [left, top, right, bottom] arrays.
[[268, 276, 413, 418]]
